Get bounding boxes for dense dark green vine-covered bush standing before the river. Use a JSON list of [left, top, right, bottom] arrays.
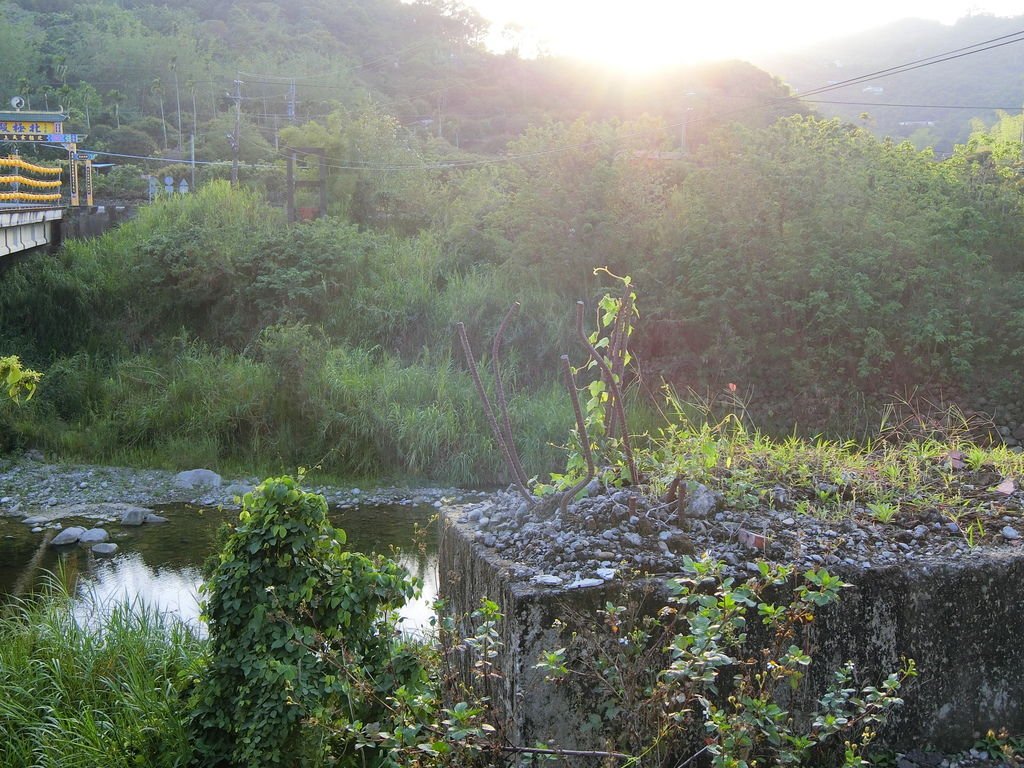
[[191, 477, 423, 766]]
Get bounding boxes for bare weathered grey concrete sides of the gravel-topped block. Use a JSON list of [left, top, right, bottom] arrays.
[[439, 512, 1024, 752]]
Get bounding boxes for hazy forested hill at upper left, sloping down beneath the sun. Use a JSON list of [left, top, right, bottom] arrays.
[[0, 0, 805, 160]]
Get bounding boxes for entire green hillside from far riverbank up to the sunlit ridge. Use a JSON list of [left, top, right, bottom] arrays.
[[6, 0, 1024, 482]]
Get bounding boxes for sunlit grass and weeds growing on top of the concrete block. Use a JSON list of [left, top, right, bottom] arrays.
[[641, 390, 1024, 544]]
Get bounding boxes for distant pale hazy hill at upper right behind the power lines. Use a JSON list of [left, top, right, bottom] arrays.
[[757, 15, 1024, 153]]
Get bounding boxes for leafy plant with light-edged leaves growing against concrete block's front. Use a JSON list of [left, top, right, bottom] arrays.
[[537, 557, 915, 768]]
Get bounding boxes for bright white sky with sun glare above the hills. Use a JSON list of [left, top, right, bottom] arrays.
[[467, 0, 1024, 71]]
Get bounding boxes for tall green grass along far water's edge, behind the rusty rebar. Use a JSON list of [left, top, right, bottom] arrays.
[[0, 333, 572, 485]]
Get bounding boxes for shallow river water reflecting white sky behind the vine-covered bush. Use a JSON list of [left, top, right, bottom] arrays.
[[0, 504, 438, 632]]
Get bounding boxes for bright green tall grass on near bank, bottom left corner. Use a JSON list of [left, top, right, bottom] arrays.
[[0, 579, 203, 768]]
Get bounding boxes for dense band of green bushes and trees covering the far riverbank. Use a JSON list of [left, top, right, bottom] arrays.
[[6, 110, 1024, 482]]
